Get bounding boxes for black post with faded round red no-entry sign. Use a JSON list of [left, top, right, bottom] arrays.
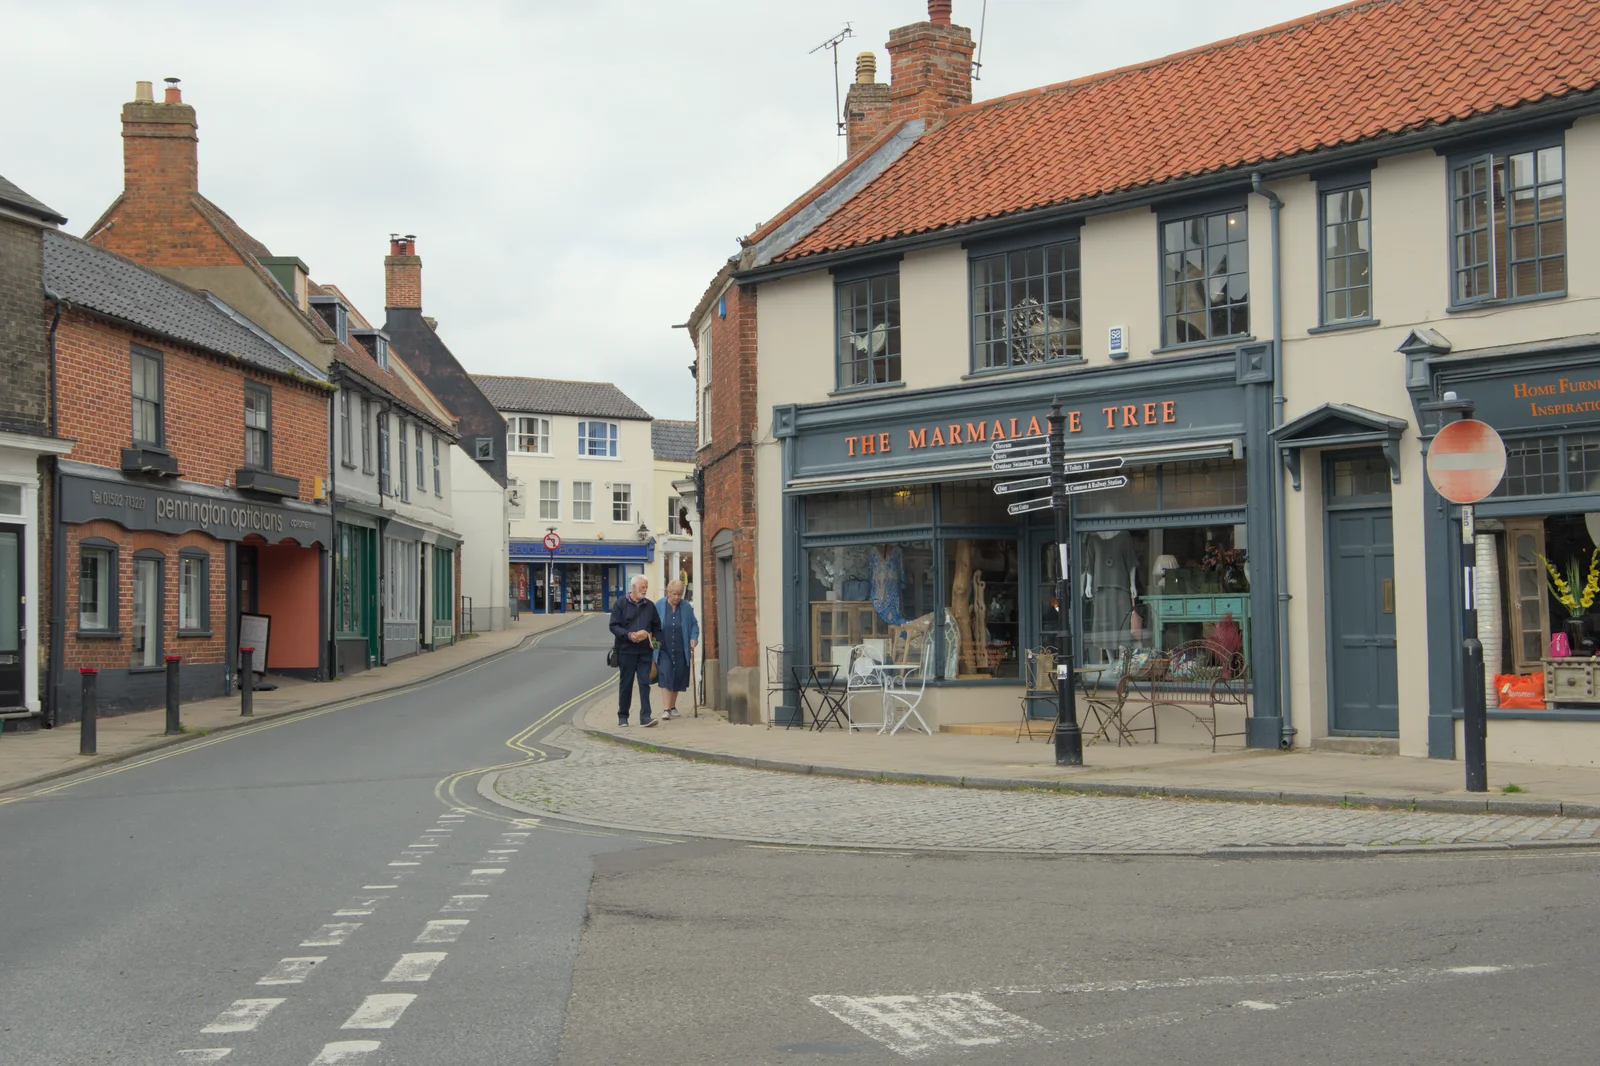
[[1424, 406, 1506, 792]]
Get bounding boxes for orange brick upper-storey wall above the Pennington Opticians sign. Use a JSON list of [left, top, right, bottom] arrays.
[[56, 311, 328, 499]]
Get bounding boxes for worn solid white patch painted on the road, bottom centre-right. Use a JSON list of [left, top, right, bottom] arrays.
[[811, 992, 1050, 1058]]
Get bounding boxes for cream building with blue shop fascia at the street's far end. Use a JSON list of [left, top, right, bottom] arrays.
[[472, 375, 658, 613]]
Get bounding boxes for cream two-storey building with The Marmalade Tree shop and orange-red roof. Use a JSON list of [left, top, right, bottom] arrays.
[[690, 0, 1600, 765]]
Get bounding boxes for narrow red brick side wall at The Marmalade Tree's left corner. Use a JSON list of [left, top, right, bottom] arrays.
[[698, 285, 762, 666]]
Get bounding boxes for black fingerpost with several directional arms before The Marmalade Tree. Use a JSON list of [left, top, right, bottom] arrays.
[[989, 400, 1128, 767]]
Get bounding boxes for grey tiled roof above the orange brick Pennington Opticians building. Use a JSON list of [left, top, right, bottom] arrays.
[[43, 230, 322, 378]]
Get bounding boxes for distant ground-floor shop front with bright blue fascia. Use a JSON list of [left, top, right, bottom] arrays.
[[510, 539, 661, 615]]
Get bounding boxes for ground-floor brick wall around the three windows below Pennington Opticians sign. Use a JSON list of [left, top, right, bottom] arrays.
[[61, 520, 227, 672]]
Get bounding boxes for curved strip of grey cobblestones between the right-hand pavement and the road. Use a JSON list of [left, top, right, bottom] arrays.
[[491, 727, 1600, 853]]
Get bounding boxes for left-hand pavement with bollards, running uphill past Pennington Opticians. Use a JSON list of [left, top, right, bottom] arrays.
[[0, 615, 579, 792]]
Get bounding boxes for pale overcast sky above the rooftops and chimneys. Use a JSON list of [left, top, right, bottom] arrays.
[[0, 0, 1328, 418]]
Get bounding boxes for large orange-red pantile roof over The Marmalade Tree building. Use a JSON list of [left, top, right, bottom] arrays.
[[778, 0, 1600, 261]]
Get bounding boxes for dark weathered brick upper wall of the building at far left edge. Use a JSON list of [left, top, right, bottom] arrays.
[[0, 218, 51, 434]]
